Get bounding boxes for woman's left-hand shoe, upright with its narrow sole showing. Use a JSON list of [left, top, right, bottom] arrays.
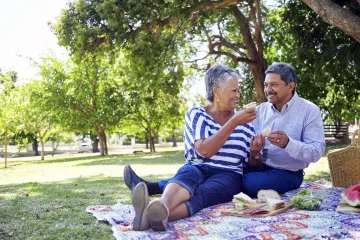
[[132, 182, 150, 231]]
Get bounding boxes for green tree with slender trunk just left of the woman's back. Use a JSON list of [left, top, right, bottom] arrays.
[[124, 31, 185, 152]]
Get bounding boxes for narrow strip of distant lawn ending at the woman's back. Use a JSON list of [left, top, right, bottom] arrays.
[[77, 151, 185, 166]]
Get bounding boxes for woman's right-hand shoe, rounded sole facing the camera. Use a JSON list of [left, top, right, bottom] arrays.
[[146, 199, 169, 231]]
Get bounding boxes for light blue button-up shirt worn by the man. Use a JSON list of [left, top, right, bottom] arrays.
[[253, 92, 325, 171]]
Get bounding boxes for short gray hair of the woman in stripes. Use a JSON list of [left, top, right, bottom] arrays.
[[205, 63, 239, 102]]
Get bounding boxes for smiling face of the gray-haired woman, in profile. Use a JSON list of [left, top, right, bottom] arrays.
[[215, 78, 240, 109]]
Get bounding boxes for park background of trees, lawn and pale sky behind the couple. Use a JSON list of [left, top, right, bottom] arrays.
[[0, 0, 360, 239]]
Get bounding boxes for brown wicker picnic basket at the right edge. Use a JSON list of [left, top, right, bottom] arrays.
[[328, 130, 360, 187]]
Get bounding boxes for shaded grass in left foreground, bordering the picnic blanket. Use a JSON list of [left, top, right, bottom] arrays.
[[0, 175, 170, 239]]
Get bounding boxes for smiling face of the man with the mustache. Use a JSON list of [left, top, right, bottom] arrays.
[[264, 73, 295, 109]]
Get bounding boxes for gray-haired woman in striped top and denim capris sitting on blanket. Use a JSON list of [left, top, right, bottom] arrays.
[[128, 64, 265, 231]]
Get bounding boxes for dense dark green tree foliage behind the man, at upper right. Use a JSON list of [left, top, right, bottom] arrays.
[[266, 0, 360, 124]]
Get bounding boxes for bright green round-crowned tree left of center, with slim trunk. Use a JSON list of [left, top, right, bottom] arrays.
[[41, 52, 128, 155]]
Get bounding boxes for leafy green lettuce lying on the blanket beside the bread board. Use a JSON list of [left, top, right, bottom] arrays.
[[290, 189, 323, 211]]
